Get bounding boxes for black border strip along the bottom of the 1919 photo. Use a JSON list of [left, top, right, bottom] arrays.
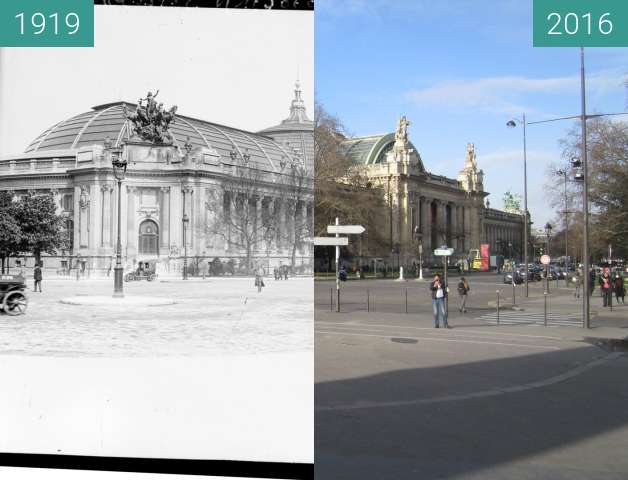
[[0, 453, 314, 480]]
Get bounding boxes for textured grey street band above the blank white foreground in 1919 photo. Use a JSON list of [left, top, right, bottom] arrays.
[[0, 278, 313, 356]]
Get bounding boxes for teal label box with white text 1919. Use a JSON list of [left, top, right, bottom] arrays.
[[0, 0, 94, 47]]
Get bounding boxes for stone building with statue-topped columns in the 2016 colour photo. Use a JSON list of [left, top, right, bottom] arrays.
[[341, 116, 524, 265]]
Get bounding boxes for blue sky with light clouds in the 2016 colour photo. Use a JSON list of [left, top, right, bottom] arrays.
[[315, 0, 628, 231]]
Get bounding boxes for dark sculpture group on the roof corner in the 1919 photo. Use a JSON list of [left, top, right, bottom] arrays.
[[123, 90, 177, 145]]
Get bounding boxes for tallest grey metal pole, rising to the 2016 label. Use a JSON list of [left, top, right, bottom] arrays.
[[580, 47, 590, 328]]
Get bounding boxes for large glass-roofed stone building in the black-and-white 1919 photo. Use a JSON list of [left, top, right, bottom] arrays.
[[0, 82, 314, 276]]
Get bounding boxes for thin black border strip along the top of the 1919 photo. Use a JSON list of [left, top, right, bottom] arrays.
[[94, 0, 314, 10]]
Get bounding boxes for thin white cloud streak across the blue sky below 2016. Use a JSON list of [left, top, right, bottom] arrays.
[[407, 69, 626, 115]]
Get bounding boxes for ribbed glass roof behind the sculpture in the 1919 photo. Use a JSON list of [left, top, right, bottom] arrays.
[[24, 102, 295, 171]]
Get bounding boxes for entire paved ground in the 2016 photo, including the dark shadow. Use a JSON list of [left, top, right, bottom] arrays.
[[315, 275, 628, 480]]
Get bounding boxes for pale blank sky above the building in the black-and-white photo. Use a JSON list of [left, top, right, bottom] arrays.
[[0, 6, 314, 156]]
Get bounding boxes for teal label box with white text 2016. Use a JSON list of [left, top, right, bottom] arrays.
[[533, 0, 628, 47]]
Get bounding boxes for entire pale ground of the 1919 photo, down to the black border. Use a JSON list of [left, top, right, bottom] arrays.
[[0, 278, 314, 462]]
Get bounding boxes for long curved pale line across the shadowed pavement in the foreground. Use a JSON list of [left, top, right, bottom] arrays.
[[314, 352, 623, 412]]
